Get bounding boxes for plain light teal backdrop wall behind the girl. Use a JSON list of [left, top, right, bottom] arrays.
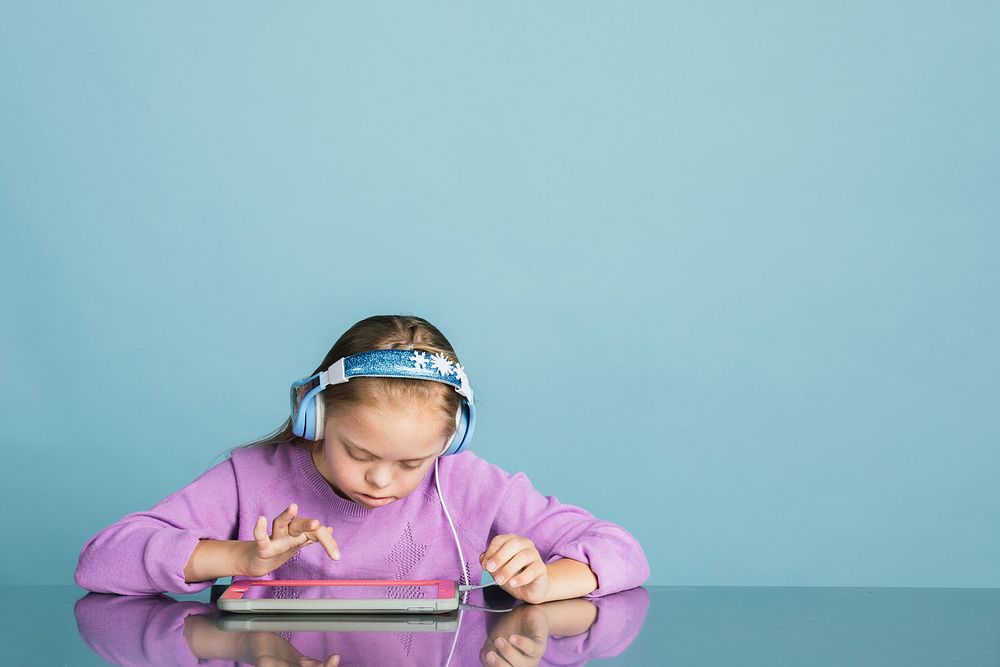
[[0, 0, 1000, 587]]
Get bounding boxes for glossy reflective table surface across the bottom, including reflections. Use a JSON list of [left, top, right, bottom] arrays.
[[0, 586, 1000, 667]]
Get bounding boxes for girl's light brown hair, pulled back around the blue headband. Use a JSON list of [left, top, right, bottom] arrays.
[[233, 315, 462, 454]]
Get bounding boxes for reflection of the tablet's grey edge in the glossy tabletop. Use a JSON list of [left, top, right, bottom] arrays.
[[216, 611, 458, 632]]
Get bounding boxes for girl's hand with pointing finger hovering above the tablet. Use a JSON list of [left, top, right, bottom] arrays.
[[240, 503, 340, 577]]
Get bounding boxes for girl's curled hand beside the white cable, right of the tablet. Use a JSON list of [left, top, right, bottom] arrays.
[[479, 535, 549, 604]]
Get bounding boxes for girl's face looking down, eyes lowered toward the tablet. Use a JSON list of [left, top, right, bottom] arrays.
[[313, 404, 451, 507]]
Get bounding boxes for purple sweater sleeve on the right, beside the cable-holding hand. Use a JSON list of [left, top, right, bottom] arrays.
[[489, 473, 649, 597]]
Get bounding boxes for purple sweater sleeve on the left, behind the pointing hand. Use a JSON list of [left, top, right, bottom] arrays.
[[75, 459, 239, 595]]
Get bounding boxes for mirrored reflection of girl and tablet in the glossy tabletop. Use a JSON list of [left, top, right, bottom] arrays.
[[74, 588, 649, 667]]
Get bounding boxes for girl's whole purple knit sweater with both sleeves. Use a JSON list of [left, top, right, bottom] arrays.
[[76, 444, 649, 597]]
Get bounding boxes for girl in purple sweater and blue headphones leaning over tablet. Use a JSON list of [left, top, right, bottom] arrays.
[[76, 316, 649, 603]]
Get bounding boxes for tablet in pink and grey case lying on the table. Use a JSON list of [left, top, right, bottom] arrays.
[[215, 579, 459, 614]]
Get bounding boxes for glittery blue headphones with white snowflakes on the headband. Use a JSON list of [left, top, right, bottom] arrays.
[[290, 349, 476, 456]]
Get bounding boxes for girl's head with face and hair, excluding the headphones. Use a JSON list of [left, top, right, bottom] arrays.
[[253, 315, 462, 507]]
